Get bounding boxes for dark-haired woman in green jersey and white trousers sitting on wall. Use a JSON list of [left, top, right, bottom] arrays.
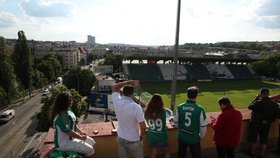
[[50, 92, 95, 158]]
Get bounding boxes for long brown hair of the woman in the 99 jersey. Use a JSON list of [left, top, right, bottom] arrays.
[[145, 94, 164, 120]]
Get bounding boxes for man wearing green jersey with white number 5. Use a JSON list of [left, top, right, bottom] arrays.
[[173, 86, 207, 158]]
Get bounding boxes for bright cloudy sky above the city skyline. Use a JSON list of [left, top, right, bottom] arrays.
[[0, 0, 280, 45]]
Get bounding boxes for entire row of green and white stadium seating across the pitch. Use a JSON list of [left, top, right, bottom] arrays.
[[123, 63, 258, 82]]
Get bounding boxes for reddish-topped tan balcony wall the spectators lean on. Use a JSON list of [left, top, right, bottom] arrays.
[[40, 110, 279, 158]]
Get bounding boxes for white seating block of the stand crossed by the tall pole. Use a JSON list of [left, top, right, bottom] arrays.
[[158, 64, 187, 81]]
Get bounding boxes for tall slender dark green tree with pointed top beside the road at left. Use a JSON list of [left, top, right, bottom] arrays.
[[13, 31, 34, 91]]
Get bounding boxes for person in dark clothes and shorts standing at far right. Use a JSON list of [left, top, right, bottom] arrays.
[[247, 88, 278, 157]]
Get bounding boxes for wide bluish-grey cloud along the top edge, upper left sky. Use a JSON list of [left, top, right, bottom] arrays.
[[21, 0, 75, 18]]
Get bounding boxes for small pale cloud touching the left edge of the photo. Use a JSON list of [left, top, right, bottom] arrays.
[[0, 12, 19, 28]]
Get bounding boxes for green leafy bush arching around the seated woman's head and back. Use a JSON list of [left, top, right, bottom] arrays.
[[37, 85, 86, 132]]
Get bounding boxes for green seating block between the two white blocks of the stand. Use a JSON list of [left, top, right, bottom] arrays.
[[185, 63, 212, 81]]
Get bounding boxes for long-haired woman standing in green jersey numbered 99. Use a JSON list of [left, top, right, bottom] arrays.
[[145, 94, 170, 158]]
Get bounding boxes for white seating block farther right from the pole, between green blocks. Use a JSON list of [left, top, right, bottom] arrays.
[[206, 64, 234, 79]]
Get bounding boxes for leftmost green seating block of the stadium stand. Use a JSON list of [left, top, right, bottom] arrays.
[[126, 64, 164, 82]]
